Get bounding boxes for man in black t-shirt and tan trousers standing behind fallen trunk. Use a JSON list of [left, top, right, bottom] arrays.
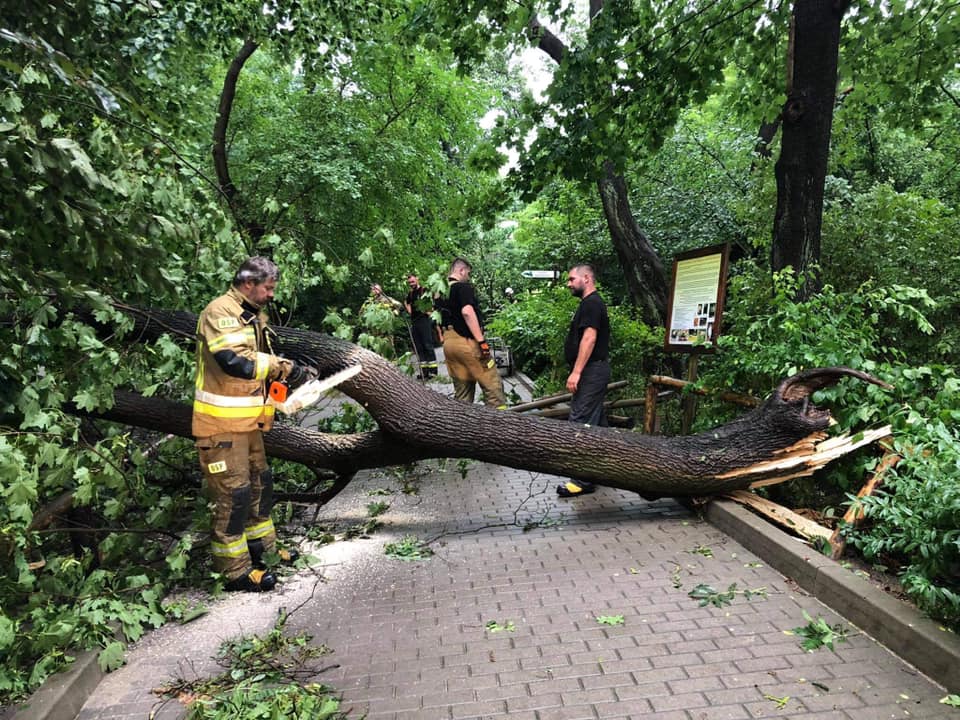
[[443, 258, 507, 409]]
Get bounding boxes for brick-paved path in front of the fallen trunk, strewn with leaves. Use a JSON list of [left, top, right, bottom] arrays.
[[79, 368, 960, 720]]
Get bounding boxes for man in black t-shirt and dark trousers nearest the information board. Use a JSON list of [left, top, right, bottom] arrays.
[[557, 265, 610, 497]]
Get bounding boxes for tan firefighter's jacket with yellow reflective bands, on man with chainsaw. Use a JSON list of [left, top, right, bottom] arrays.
[[193, 287, 292, 438]]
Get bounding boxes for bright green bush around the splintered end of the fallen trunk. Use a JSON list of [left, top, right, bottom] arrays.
[[700, 267, 960, 628]]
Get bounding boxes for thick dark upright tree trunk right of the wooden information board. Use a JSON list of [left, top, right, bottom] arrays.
[[770, 0, 849, 299]]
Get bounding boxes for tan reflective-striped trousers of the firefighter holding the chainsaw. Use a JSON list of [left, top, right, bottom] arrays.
[[197, 430, 277, 580]]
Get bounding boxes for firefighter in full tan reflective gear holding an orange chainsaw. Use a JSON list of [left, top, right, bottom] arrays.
[[193, 257, 311, 592]]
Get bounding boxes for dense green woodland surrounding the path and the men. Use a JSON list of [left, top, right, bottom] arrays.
[[0, 0, 960, 705]]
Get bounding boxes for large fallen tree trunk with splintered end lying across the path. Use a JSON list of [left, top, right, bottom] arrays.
[[105, 310, 889, 496]]
